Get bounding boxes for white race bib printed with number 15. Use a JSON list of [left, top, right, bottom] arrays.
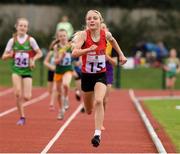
[[86, 55, 106, 73]]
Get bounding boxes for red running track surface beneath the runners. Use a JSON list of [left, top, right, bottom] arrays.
[[0, 87, 180, 153]]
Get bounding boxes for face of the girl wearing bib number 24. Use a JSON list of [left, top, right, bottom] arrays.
[[16, 20, 28, 35]]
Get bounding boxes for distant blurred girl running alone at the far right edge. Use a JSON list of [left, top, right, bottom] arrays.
[[164, 49, 180, 96]]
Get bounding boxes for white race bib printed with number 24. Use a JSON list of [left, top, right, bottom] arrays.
[[14, 52, 29, 68]]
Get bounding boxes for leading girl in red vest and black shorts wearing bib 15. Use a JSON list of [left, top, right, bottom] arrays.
[[72, 10, 127, 147]]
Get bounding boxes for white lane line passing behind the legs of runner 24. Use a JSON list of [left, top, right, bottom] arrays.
[[0, 92, 49, 117]]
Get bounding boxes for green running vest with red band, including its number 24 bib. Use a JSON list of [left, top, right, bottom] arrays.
[[12, 36, 32, 76]]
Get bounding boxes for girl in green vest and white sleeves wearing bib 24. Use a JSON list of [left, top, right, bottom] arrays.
[[2, 18, 42, 125]]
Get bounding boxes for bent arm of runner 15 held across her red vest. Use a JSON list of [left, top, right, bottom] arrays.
[[72, 31, 97, 58]]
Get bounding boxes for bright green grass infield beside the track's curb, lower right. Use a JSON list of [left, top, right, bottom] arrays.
[[144, 99, 180, 152]]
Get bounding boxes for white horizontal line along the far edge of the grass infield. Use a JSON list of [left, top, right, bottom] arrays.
[[137, 95, 180, 100]]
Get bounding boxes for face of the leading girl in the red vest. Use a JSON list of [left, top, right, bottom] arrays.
[[86, 11, 101, 30]]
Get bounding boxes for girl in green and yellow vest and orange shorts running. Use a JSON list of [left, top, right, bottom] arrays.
[[54, 29, 73, 120]]
